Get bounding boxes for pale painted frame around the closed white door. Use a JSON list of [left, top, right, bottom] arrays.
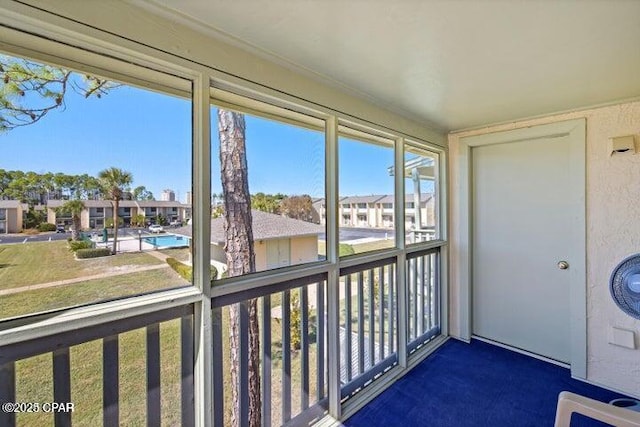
[[453, 118, 587, 379]]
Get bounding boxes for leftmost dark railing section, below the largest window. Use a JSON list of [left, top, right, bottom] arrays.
[[0, 304, 195, 427]]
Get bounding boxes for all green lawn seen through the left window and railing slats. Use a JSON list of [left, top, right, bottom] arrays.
[[5, 242, 328, 426]]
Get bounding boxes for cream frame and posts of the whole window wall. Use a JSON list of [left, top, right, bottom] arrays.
[[0, 14, 448, 425]]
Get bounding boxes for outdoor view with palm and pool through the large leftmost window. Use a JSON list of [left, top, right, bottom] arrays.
[[0, 51, 191, 319]]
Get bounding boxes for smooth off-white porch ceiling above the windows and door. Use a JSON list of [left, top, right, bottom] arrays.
[[138, 0, 640, 130]]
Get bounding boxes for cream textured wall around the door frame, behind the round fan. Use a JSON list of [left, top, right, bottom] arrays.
[[449, 102, 640, 397]]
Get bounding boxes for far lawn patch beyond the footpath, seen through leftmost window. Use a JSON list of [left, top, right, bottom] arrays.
[[0, 241, 162, 289]]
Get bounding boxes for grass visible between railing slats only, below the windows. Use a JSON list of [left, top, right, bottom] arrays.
[[16, 302, 317, 427]]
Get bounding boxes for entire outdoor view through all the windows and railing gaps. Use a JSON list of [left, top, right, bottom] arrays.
[[0, 49, 438, 426]]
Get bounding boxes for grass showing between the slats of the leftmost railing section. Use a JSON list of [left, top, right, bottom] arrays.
[[16, 320, 181, 427]]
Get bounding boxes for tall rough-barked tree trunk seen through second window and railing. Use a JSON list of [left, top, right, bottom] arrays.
[[218, 110, 262, 427]]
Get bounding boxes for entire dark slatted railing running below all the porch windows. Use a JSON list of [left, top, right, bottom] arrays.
[[0, 247, 441, 426]]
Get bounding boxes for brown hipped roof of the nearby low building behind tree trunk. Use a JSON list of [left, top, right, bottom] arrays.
[[173, 209, 325, 244]]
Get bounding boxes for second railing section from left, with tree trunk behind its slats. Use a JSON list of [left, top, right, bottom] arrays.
[[213, 275, 328, 426]]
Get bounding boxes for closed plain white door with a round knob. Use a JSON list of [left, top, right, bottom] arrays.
[[470, 123, 584, 363]]
